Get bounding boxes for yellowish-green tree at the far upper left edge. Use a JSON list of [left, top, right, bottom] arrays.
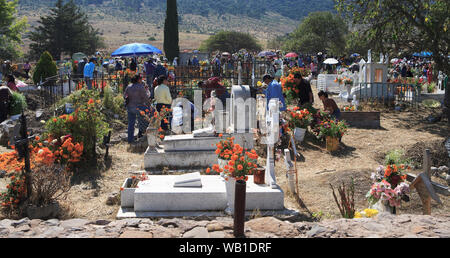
[[0, 0, 27, 59]]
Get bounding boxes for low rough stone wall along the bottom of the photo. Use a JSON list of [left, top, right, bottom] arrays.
[[0, 213, 450, 238]]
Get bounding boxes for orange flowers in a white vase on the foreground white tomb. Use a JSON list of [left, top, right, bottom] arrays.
[[212, 144, 258, 214]]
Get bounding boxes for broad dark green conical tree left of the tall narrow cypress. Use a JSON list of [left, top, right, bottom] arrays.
[[30, 0, 104, 60]]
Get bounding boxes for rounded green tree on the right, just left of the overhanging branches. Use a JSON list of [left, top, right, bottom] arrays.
[[283, 12, 348, 55]]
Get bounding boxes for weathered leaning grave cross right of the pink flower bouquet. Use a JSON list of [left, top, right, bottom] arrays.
[[410, 149, 442, 215]]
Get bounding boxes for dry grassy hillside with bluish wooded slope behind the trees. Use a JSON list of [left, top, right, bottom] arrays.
[[19, 0, 333, 51]]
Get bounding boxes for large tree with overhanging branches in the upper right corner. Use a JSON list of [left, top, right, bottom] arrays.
[[335, 0, 450, 121]]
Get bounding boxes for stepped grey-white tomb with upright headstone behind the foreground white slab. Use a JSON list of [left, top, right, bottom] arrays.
[[144, 86, 256, 170]]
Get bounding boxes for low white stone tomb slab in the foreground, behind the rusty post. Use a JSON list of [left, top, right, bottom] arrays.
[[117, 173, 284, 218]]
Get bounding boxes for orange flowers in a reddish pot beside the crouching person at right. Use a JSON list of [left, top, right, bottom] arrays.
[[319, 120, 348, 152]]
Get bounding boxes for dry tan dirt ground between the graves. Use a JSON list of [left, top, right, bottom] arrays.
[[0, 95, 450, 222]]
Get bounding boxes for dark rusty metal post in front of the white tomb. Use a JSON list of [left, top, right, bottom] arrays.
[[234, 180, 247, 238]]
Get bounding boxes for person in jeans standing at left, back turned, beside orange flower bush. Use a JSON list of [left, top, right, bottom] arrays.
[[124, 75, 150, 143]]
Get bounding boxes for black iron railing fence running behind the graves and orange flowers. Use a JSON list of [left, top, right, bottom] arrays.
[[37, 61, 275, 106]]
